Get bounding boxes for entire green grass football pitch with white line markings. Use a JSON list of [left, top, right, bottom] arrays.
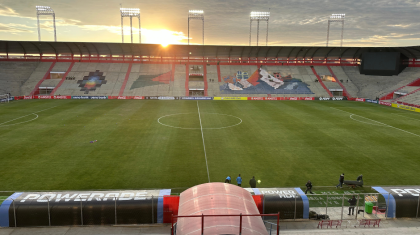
[[0, 100, 420, 191]]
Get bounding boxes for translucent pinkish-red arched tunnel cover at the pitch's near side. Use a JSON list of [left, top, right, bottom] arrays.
[[176, 183, 268, 235]]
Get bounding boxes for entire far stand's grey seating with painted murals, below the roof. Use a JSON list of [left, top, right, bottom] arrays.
[[0, 61, 420, 99]]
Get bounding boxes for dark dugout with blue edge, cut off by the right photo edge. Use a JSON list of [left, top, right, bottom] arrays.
[[372, 186, 420, 218]]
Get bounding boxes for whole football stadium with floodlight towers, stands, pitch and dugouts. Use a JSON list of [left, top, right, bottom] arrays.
[[0, 1, 420, 234]]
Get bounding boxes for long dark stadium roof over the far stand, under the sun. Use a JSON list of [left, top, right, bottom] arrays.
[[0, 41, 420, 59]]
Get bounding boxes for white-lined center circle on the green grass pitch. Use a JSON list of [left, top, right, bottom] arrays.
[[157, 113, 242, 130]]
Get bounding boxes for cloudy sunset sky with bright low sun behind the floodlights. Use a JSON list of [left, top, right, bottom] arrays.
[[0, 0, 420, 46]]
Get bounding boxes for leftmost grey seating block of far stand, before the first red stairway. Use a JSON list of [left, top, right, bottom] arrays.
[[0, 61, 38, 96]]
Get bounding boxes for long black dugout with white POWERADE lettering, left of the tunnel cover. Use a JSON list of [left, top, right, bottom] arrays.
[[0, 189, 171, 227]]
